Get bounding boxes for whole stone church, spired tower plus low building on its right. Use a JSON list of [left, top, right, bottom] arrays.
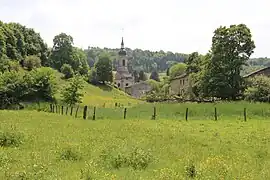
[[114, 37, 152, 98]]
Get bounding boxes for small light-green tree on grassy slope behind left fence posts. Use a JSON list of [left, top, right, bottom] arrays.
[[62, 76, 84, 106]]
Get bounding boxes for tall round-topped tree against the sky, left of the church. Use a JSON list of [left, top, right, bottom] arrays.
[[50, 33, 74, 70]]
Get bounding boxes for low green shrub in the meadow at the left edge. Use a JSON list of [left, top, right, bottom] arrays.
[[0, 132, 22, 147]]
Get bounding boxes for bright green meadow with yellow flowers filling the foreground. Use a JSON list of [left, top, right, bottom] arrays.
[[0, 104, 270, 180]]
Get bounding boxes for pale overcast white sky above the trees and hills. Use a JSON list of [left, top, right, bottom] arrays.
[[0, 0, 270, 57]]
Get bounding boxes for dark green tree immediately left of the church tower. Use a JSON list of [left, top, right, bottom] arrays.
[[95, 53, 113, 83]]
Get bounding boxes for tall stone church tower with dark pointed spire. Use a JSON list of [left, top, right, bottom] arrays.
[[114, 38, 134, 91]]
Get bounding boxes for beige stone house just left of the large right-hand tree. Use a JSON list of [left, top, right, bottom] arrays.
[[170, 74, 191, 96]]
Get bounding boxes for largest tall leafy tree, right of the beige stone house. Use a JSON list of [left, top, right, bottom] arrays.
[[202, 24, 255, 100]]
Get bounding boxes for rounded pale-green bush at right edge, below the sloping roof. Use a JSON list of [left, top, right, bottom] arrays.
[[244, 76, 270, 102]]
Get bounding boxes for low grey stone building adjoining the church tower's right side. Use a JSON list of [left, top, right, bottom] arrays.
[[126, 81, 152, 98]]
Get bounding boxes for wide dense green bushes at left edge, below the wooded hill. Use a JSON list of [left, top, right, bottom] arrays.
[[0, 67, 56, 109]]
